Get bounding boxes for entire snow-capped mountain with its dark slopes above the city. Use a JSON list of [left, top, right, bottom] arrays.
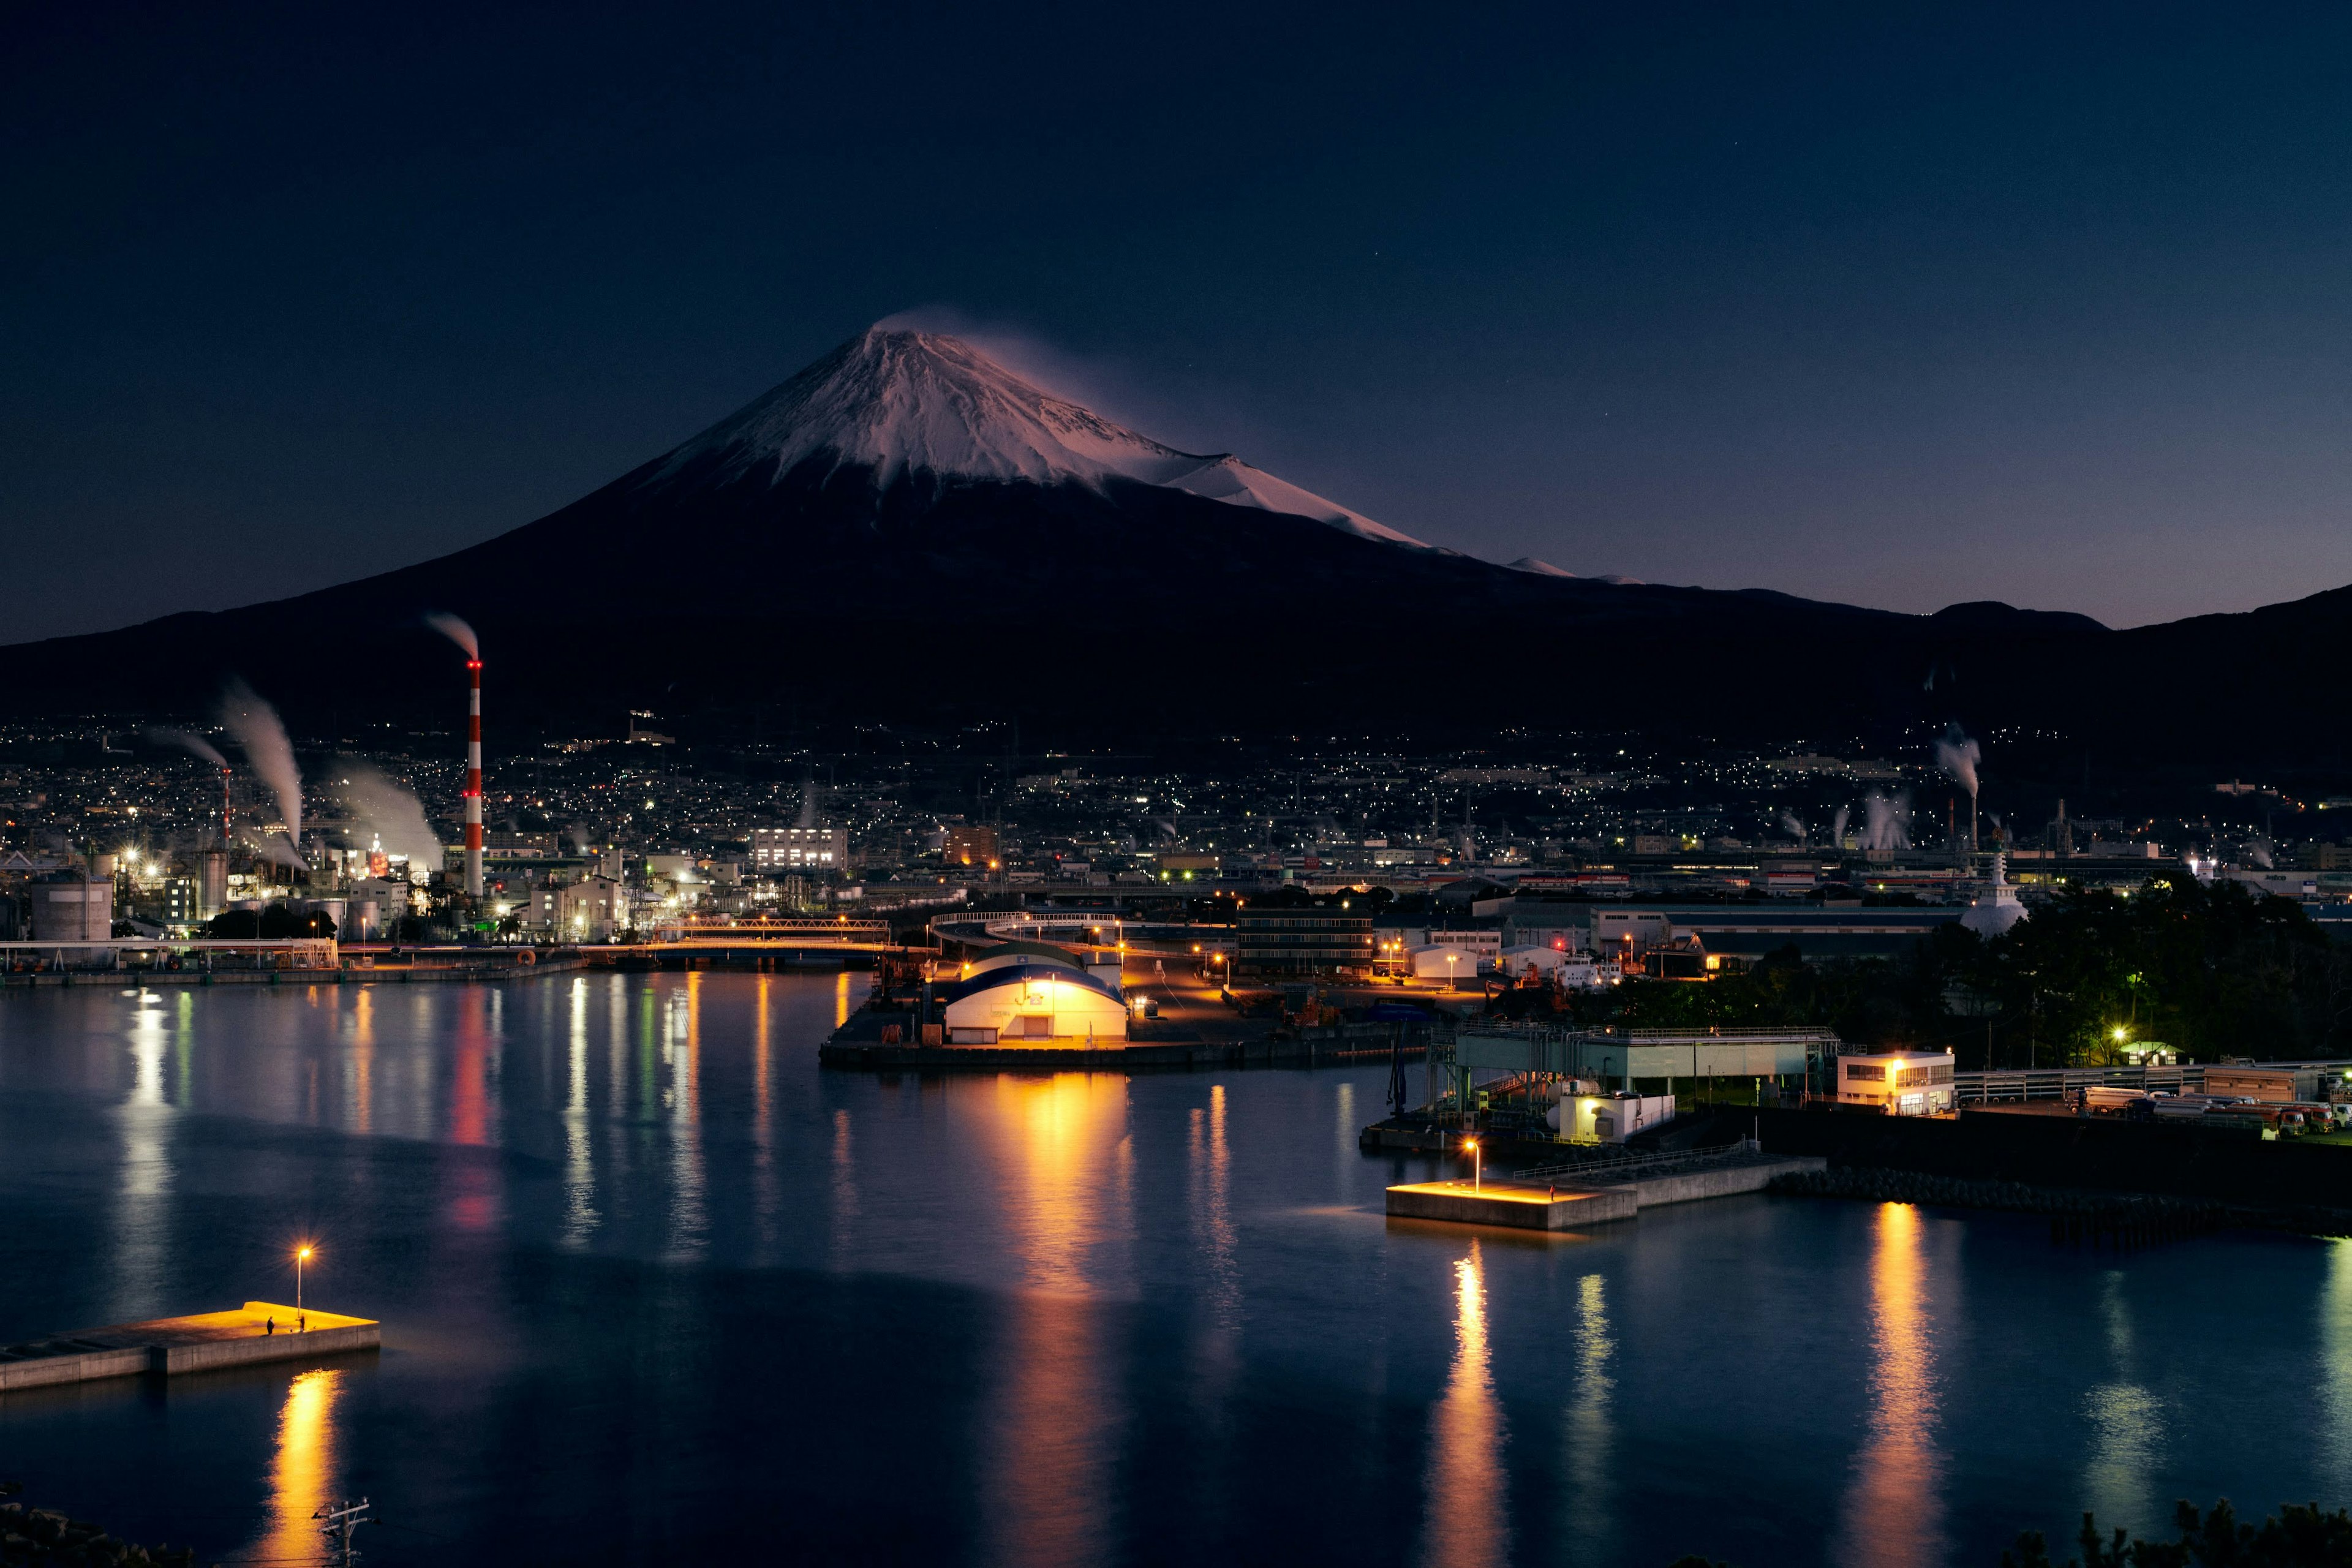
[[0, 326, 2352, 755]]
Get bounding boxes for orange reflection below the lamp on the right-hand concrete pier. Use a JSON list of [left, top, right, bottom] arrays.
[[1420, 1239, 1510, 1568]]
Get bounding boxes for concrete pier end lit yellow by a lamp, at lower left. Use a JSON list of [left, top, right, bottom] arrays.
[[0, 1302, 383, 1392]]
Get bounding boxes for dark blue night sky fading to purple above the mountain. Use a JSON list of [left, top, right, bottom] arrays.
[[0, 2, 2352, 642]]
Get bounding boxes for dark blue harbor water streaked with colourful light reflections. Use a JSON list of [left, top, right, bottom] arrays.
[[0, 973, 2352, 1568]]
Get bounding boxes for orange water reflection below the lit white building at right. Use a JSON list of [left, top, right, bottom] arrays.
[[1842, 1204, 1945, 1568]]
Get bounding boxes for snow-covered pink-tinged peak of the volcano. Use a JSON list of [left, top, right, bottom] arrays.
[[647, 326, 1428, 550]]
